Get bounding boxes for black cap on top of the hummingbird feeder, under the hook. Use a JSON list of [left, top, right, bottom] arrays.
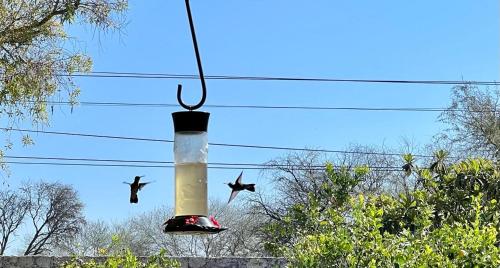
[[172, 111, 210, 132]]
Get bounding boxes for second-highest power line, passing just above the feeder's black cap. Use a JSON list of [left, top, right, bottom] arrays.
[[46, 101, 478, 113]]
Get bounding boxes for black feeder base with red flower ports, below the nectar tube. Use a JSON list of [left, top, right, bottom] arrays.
[[163, 216, 227, 235]]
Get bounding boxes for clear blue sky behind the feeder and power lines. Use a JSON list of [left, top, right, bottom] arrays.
[[1, 0, 500, 249]]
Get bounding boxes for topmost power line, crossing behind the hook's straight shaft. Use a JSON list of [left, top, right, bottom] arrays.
[[62, 71, 500, 86]]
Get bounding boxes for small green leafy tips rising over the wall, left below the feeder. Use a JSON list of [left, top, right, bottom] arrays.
[[61, 236, 181, 268]]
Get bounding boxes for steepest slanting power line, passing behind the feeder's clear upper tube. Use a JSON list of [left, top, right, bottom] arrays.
[[0, 128, 433, 158]]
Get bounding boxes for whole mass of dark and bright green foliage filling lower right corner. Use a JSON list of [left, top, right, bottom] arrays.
[[268, 156, 500, 267]]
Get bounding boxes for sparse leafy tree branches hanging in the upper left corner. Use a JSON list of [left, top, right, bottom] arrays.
[[0, 0, 127, 147]]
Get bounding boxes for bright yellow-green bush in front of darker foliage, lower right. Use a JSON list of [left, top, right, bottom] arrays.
[[283, 196, 500, 267]]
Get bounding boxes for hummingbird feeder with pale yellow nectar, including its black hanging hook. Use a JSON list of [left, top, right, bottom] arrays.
[[164, 0, 225, 234]]
